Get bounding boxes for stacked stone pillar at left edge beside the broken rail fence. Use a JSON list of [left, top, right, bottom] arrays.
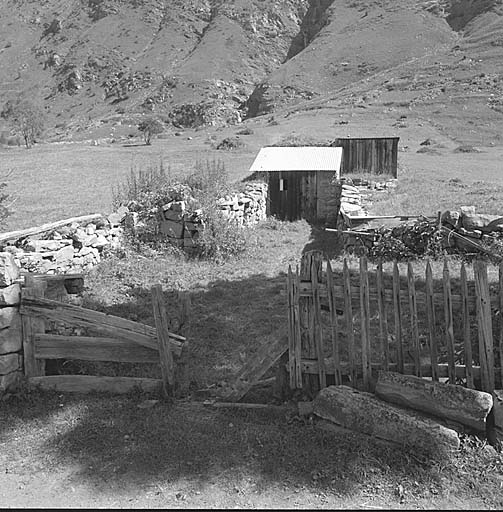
[[0, 252, 23, 395]]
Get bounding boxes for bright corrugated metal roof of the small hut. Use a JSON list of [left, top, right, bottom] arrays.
[[250, 146, 342, 173]]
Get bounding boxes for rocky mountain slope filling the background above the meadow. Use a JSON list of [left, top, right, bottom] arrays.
[[0, 0, 503, 141]]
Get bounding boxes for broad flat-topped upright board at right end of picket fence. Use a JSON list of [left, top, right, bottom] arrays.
[[473, 261, 495, 393]]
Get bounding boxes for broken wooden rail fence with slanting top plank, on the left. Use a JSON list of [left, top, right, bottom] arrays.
[[20, 278, 186, 395]]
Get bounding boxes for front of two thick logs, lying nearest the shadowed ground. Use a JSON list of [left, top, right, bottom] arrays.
[[313, 386, 459, 458]]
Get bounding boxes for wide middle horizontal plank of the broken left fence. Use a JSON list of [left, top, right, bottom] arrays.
[[34, 334, 159, 363]]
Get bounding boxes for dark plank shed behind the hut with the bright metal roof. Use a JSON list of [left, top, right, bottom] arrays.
[[331, 137, 400, 178]]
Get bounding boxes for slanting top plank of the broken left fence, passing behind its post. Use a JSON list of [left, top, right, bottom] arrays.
[[21, 297, 185, 356]]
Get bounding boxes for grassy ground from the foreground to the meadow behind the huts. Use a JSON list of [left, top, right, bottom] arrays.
[[0, 117, 503, 508]]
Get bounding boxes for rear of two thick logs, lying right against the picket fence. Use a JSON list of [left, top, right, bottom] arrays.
[[375, 371, 493, 432]]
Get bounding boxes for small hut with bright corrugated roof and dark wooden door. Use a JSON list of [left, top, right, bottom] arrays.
[[250, 146, 342, 223]]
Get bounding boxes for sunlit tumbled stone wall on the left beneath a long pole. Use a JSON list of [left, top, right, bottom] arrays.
[[2, 208, 127, 274]]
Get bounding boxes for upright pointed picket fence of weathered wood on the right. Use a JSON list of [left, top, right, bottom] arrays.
[[287, 251, 503, 392]]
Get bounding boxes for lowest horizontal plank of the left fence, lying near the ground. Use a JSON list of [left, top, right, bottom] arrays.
[[28, 375, 162, 394]]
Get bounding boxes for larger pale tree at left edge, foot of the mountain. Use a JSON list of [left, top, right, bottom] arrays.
[[0, 100, 45, 149]]
